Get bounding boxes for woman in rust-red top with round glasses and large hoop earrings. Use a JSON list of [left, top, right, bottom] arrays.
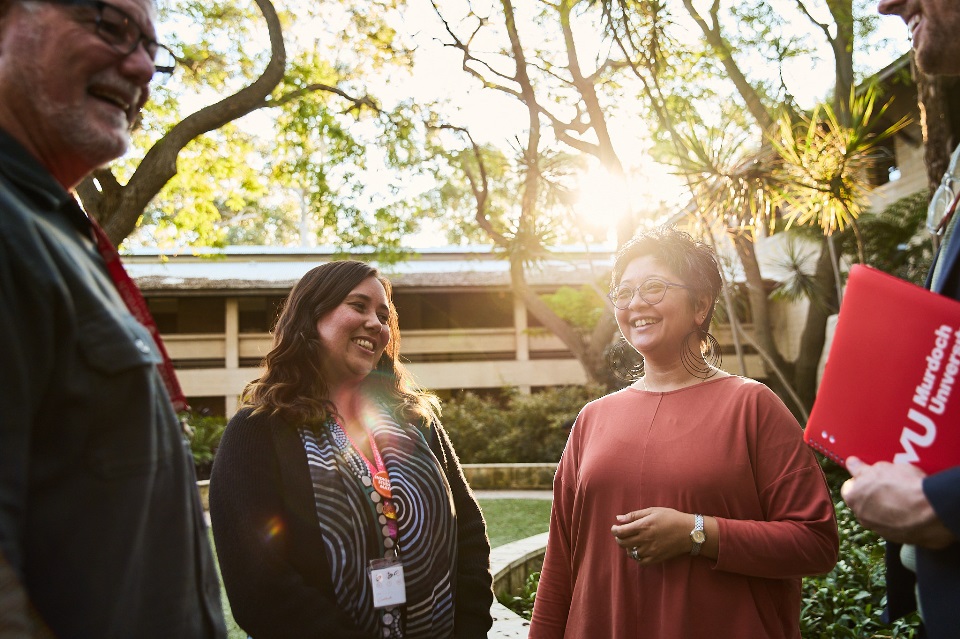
[[530, 229, 839, 639]]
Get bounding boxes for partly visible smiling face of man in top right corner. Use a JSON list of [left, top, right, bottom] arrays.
[[877, 0, 960, 75]]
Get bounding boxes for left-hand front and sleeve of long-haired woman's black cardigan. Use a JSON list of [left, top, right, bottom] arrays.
[[210, 410, 371, 639]]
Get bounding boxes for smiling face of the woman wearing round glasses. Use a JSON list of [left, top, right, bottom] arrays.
[[616, 255, 709, 362]]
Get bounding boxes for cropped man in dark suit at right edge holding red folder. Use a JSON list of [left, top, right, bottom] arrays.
[[842, 0, 960, 639]]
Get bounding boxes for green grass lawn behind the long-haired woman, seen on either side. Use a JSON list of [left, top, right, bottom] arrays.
[[210, 499, 551, 639]]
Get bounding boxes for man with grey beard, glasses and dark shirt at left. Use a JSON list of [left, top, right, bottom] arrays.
[[0, 0, 226, 639]]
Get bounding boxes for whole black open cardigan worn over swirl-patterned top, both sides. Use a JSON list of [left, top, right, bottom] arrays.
[[210, 408, 493, 639]]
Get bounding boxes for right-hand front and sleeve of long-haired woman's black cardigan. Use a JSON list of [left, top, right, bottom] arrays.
[[430, 424, 493, 639]]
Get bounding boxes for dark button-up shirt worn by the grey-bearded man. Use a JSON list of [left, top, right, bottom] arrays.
[[0, 131, 226, 639]]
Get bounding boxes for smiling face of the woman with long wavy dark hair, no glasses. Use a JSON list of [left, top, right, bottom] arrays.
[[317, 277, 390, 388]]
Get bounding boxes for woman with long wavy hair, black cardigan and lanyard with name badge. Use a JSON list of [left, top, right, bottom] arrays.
[[210, 261, 493, 639]]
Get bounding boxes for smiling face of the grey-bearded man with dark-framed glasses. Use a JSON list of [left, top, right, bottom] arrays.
[[0, 0, 156, 188]]
